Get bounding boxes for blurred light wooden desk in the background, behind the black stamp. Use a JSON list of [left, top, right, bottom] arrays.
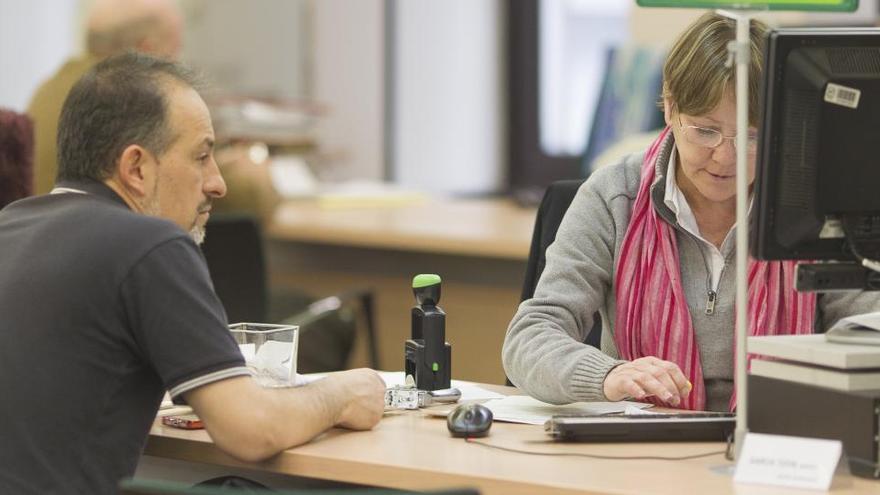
[[267, 199, 535, 383]]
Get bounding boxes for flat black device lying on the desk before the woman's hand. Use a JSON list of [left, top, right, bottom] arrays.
[[544, 412, 736, 442]]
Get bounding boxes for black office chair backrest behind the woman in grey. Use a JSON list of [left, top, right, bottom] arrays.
[[521, 179, 602, 348]]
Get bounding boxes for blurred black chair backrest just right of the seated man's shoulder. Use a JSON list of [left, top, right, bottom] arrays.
[[202, 214, 268, 323]]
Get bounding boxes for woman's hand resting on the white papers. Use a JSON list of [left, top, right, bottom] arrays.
[[602, 356, 693, 406]]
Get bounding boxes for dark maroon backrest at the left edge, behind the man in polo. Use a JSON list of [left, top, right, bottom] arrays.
[[0, 109, 34, 209]]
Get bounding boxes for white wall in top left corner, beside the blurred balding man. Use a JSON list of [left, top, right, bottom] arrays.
[[0, 0, 79, 112]]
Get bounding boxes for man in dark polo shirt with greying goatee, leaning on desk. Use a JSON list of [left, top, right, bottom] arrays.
[[0, 54, 384, 494]]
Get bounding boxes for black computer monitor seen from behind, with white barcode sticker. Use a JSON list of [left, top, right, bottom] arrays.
[[751, 28, 880, 272]]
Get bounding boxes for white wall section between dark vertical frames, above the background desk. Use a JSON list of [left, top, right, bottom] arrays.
[[389, 0, 506, 193]]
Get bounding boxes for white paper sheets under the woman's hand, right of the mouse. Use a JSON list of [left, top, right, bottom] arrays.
[[484, 395, 651, 425]]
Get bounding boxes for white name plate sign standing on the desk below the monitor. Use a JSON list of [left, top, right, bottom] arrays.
[[733, 433, 843, 490]]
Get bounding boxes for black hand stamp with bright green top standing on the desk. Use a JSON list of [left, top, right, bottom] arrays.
[[404, 274, 452, 390]]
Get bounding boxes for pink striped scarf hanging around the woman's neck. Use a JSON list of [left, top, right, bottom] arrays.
[[614, 128, 816, 411]]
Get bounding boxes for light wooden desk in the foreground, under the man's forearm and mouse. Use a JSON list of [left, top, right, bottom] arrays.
[[145, 387, 880, 495]]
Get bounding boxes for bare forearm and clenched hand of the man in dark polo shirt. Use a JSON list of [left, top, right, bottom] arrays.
[[184, 369, 385, 461]]
